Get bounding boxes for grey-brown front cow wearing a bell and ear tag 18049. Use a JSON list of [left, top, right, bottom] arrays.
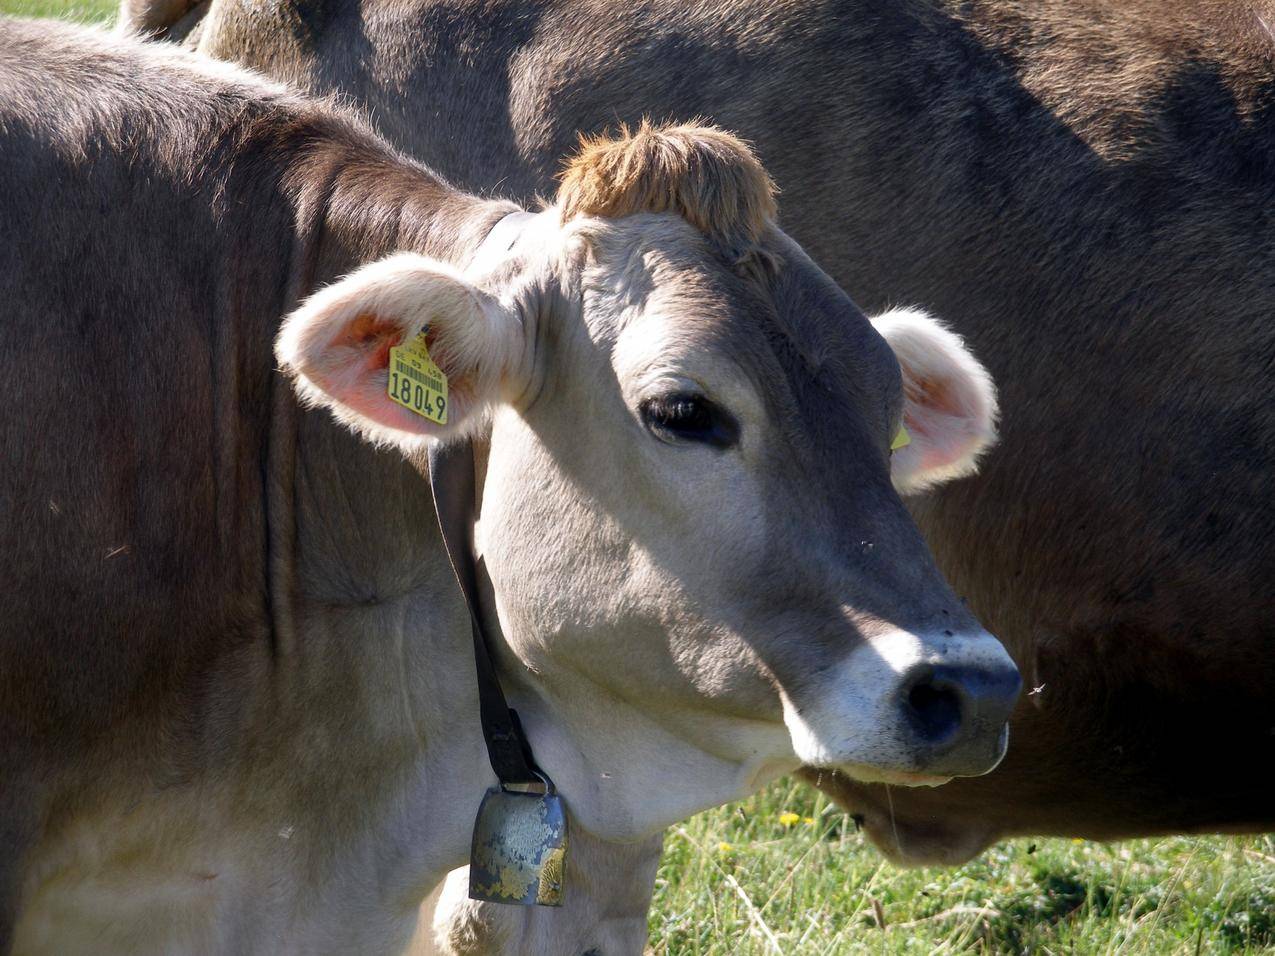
[[0, 20, 1019, 953]]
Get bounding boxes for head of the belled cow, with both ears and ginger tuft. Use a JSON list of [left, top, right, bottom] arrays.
[[277, 126, 1019, 839]]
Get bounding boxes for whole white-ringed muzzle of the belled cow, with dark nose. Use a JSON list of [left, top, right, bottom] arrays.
[[784, 631, 1023, 785]]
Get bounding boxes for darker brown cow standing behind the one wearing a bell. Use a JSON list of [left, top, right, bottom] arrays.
[[142, 0, 1275, 862]]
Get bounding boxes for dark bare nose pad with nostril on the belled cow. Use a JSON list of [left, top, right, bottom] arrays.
[[900, 664, 1023, 776]]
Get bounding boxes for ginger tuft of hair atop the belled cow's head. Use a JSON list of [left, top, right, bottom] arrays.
[[557, 120, 778, 261]]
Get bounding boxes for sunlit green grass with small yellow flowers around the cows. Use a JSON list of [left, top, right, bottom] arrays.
[[9, 0, 1275, 956]]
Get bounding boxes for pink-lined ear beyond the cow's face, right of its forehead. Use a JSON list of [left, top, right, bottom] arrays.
[[872, 308, 997, 495]]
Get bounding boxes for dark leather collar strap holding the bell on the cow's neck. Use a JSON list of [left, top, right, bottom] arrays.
[[430, 441, 553, 793]]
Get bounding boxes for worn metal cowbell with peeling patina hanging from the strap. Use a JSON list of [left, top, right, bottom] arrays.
[[469, 784, 566, 906]]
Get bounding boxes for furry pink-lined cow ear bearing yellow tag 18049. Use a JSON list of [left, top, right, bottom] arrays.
[[274, 252, 523, 451]]
